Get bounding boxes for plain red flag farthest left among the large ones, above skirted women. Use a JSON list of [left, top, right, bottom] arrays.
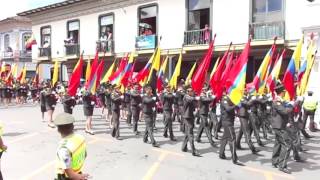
[[68, 55, 83, 96]]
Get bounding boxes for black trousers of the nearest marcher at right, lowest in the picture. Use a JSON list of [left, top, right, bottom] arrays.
[[272, 129, 292, 168]]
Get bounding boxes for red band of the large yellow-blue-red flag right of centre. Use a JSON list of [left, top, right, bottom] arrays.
[[224, 39, 251, 89]]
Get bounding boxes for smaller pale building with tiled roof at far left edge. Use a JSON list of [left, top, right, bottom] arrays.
[[0, 16, 36, 77]]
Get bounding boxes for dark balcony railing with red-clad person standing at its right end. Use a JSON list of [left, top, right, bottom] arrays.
[[184, 29, 211, 46]]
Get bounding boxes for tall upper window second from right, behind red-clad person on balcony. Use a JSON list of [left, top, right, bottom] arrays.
[[187, 0, 210, 30]]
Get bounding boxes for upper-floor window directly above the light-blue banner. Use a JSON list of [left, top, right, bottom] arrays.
[[138, 5, 158, 36]]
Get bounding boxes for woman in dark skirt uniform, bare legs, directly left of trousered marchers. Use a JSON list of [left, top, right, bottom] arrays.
[[82, 91, 95, 135]]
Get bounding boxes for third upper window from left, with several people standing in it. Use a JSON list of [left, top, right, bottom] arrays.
[[99, 14, 114, 40]]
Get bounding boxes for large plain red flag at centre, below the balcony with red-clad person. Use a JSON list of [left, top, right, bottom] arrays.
[[191, 36, 216, 95]]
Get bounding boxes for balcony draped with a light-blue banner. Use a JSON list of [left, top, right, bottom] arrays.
[[136, 34, 157, 50]]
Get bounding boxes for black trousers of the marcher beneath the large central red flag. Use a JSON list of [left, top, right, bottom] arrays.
[[181, 118, 196, 152]]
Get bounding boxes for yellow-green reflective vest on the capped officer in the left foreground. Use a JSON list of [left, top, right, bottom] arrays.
[[57, 134, 86, 177]]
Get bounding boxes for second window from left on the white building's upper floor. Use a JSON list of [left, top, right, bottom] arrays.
[[65, 20, 80, 44]]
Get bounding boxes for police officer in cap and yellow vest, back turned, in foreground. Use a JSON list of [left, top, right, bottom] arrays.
[[54, 113, 89, 180]]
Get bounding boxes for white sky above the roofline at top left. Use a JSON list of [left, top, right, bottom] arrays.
[[0, 0, 64, 20]]
